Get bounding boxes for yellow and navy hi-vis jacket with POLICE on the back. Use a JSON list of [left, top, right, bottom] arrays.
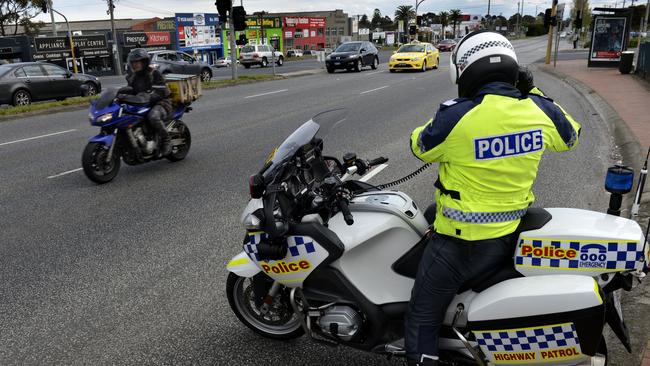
[[411, 83, 580, 241]]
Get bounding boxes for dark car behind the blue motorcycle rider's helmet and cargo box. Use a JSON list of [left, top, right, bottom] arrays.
[[127, 51, 212, 81]]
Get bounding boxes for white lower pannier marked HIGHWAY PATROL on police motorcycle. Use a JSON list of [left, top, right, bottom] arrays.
[[467, 275, 605, 365]]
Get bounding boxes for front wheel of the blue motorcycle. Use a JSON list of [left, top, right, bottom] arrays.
[[81, 142, 120, 184]]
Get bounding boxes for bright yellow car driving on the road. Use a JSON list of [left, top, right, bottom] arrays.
[[388, 42, 440, 72]]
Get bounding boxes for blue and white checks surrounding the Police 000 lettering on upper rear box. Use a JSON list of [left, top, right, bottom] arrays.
[[515, 239, 643, 270]]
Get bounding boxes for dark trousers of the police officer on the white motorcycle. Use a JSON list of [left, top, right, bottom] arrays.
[[404, 234, 514, 361]]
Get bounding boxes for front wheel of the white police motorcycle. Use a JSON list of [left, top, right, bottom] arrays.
[[226, 273, 305, 340]]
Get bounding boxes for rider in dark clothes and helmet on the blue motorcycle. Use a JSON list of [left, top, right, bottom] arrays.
[[126, 48, 172, 156]]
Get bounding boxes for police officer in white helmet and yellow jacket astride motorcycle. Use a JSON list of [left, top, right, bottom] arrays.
[[405, 30, 580, 365]]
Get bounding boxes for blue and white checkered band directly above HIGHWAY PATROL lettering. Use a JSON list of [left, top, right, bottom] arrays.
[[474, 323, 580, 352]]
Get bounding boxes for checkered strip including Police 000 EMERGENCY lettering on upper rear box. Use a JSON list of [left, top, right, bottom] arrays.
[[515, 238, 643, 272]]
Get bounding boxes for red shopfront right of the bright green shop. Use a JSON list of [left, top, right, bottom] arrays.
[[282, 16, 327, 50]]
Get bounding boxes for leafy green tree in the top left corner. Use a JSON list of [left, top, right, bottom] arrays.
[[0, 0, 46, 36]]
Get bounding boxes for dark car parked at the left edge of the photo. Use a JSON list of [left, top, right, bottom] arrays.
[[0, 62, 102, 106]]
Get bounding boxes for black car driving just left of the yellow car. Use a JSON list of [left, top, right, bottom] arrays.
[[325, 41, 379, 74]]
